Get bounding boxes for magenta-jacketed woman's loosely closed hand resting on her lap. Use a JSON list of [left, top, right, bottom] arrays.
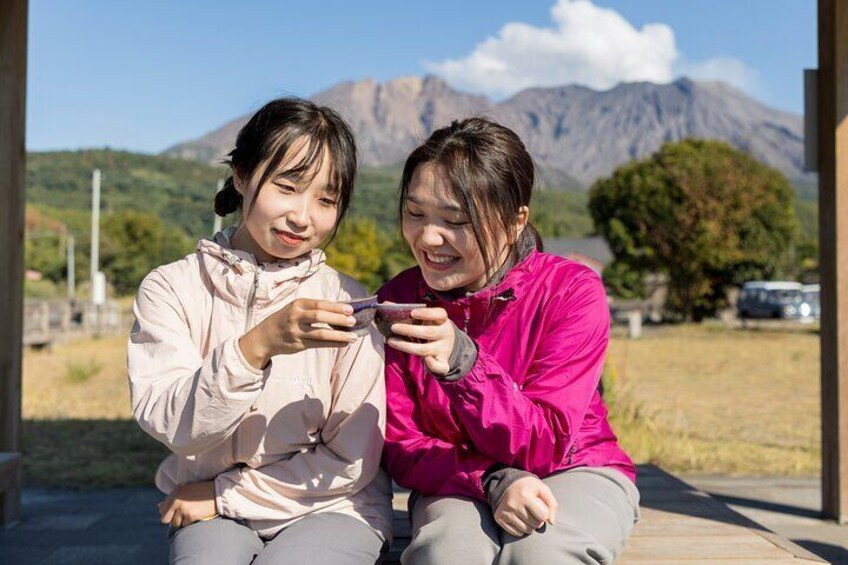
[[494, 477, 559, 538]]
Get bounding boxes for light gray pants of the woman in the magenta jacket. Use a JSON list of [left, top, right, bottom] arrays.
[[401, 467, 639, 565]]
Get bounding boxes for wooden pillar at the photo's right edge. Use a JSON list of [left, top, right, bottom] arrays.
[[818, 0, 848, 523]]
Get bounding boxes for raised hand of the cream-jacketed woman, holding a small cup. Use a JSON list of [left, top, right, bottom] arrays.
[[239, 298, 357, 369]]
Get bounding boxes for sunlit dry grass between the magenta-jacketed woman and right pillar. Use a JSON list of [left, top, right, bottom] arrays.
[[608, 325, 821, 475]]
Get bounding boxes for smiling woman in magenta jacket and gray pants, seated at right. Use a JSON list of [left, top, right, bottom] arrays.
[[380, 118, 639, 565]]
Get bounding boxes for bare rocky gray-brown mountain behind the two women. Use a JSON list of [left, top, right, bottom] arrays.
[[165, 76, 810, 187]]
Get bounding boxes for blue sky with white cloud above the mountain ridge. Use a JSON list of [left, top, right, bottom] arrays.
[[27, 0, 816, 152]]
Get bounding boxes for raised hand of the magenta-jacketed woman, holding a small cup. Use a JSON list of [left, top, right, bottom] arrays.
[[386, 308, 455, 375]]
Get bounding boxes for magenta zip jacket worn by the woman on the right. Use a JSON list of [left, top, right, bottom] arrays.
[[379, 251, 636, 501]]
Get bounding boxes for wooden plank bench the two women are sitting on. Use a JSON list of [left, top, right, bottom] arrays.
[[383, 465, 826, 565]]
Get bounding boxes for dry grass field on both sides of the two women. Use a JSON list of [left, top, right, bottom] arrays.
[[23, 325, 820, 487]]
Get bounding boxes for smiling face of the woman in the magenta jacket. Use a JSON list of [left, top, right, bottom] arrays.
[[401, 163, 508, 292]]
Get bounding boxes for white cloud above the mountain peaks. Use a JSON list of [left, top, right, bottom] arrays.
[[424, 0, 756, 98]]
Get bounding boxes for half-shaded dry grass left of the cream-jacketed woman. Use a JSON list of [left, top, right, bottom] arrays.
[[23, 335, 167, 488]]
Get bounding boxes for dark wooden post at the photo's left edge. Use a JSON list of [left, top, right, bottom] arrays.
[[0, 0, 28, 524]]
